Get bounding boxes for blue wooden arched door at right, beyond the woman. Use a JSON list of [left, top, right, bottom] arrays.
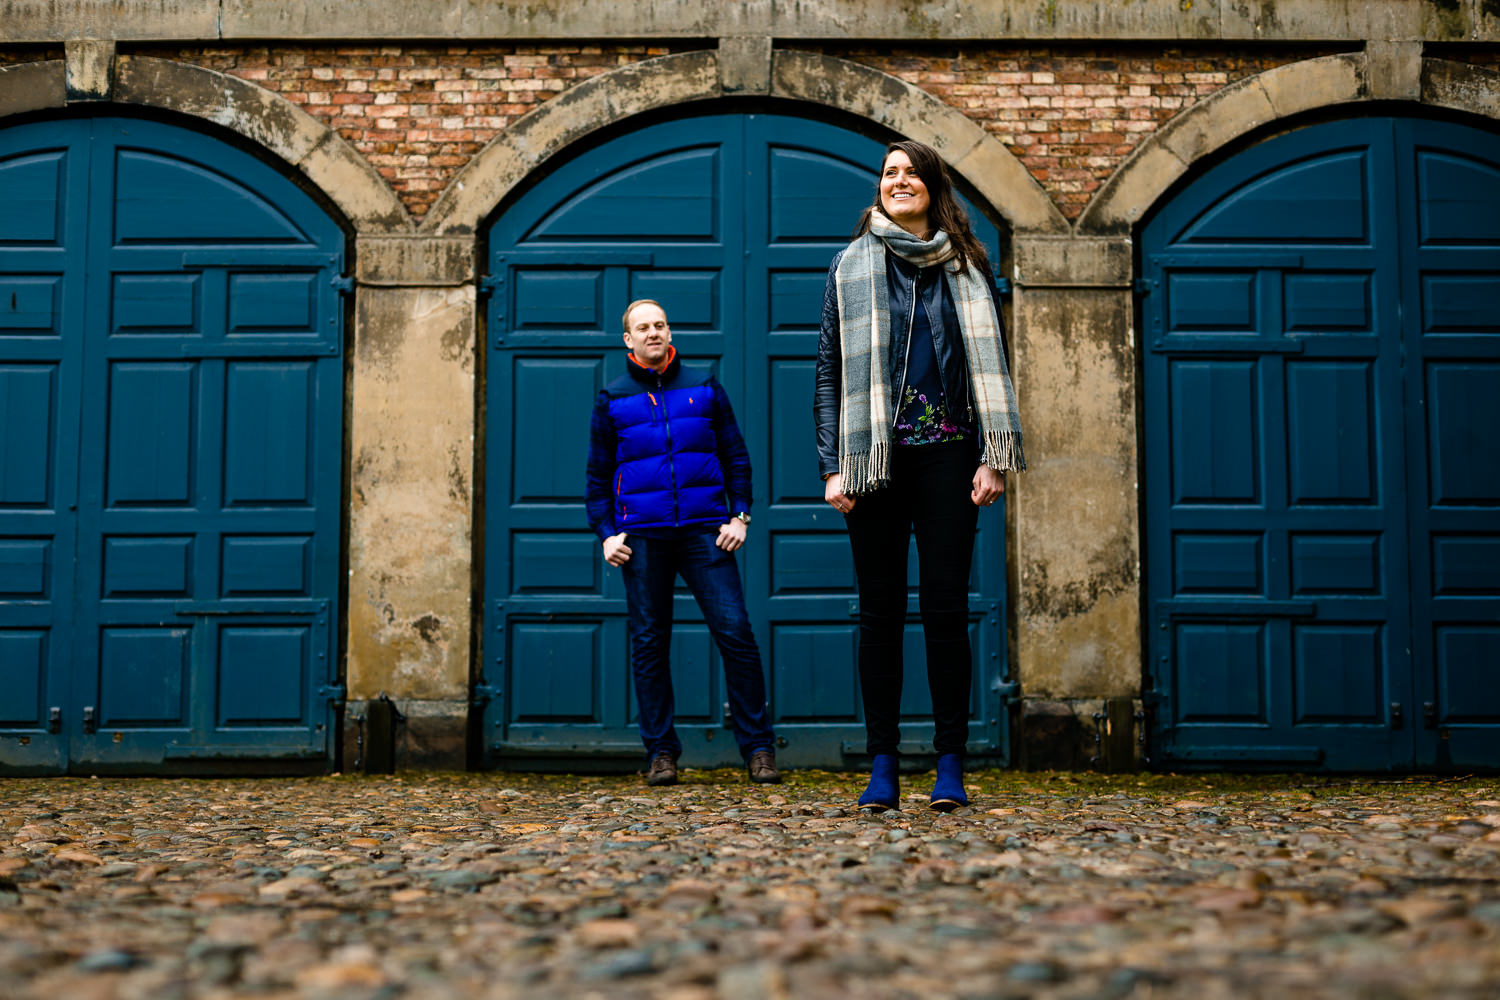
[[1142, 118, 1500, 769]]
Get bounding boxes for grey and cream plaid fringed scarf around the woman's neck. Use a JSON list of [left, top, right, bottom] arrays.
[[834, 211, 1026, 496]]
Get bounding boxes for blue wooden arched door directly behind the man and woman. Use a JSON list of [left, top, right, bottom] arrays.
[[480, 114, 1005, 766]]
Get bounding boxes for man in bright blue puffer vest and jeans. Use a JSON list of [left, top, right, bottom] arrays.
[[587, 298, 782, 786]]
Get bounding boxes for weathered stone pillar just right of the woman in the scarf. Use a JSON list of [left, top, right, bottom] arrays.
[[1011, 234, 1142, 768]]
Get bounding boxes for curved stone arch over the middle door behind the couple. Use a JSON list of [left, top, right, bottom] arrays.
[[422, 49, 1068, 235]]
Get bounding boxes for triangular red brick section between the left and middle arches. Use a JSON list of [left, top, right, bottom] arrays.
[[138, 45, 698, 217]]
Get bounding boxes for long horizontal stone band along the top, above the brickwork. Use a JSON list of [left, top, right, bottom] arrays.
[[0, 0, 1500, 42]]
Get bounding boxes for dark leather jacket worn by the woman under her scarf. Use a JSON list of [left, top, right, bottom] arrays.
[[813, 250, 1004, 477]]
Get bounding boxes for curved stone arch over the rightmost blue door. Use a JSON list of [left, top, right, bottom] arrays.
[[1076, 52, 1500, 235]]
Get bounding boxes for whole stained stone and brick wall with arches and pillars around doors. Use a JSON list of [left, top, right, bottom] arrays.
[[0, 0, 1500, 766]]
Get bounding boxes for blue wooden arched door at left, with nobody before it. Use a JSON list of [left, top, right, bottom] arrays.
[[0, 118, 344, 772]]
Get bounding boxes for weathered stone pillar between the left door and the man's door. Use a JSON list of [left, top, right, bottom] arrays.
[[345, 237, 477, 769]]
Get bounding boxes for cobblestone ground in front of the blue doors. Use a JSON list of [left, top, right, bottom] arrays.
[[0, 771, 1500, 1000]]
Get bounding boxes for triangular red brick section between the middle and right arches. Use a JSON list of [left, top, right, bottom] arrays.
[[819, 46, 1340, 219]]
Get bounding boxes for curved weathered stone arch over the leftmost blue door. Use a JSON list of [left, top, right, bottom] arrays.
[[0, 55, 411, 234]]
